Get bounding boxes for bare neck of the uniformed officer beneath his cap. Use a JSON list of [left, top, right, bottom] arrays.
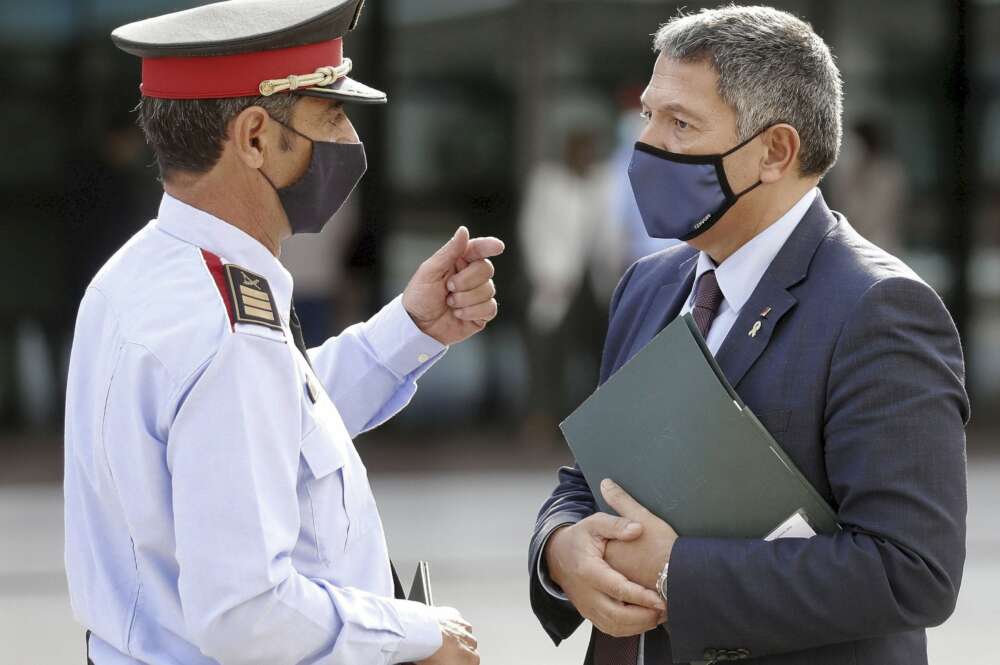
[[163, 170, 288, 256]]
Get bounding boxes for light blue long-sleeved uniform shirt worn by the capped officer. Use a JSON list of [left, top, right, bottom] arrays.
[[65, 195, 445, 665]]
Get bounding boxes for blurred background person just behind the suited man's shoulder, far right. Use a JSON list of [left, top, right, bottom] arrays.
[[830, 118, 907, 255]]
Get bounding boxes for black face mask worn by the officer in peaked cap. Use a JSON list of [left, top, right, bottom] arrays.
[[260, 118, 368, 234]]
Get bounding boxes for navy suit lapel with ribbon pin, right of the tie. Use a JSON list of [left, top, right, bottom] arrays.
[[715, 193, 837, 388]]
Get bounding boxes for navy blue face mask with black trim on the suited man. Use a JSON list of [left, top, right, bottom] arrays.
[[628, 128, 766, 241]]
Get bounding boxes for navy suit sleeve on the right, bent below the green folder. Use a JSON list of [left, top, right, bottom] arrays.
[[667, 278, 969, 662]]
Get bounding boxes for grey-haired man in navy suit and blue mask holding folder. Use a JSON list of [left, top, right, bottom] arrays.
[[530, 7, 969, 665]]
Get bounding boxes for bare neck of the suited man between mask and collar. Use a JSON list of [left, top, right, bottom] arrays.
[[688, 179, 819, 265]]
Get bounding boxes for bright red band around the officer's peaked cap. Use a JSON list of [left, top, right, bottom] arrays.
[[139, 37, 344, 99]]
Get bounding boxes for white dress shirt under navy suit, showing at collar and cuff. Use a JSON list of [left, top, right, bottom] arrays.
[[537, 188, 819, 665]]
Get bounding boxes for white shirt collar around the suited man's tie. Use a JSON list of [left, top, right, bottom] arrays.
[[692, 187, 819, 312]]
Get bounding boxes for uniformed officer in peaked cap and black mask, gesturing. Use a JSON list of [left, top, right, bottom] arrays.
[[65, 0, 503, 665]]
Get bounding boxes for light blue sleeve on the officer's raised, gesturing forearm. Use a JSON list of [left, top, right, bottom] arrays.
[[309, 296, 447, 437]]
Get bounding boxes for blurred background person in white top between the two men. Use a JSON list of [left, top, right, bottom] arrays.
[[518, 128, 624, 444]]
